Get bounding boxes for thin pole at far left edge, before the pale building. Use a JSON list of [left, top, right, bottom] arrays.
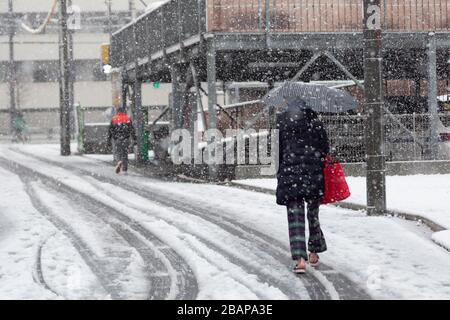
[[8, 0, 17, 134]]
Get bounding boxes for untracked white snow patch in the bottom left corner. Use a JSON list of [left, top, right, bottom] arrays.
[[0, 168, 101, 300]]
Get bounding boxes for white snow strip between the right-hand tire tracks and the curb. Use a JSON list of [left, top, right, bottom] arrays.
[[127, 178, 450, 299]]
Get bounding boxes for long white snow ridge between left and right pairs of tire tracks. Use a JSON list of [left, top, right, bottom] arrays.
[[2, 146, 296, 300]]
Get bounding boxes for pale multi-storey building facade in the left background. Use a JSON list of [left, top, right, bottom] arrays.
[[0, 0, 172, 135]]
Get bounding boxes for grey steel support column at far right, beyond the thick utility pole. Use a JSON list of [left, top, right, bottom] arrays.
[[427, 33, 439, 160]]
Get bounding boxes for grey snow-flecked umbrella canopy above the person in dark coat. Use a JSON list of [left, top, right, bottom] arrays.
[[262, 81, 358, 113]]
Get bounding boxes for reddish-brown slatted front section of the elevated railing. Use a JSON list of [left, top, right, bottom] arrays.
[[208, 0, 450, 32]]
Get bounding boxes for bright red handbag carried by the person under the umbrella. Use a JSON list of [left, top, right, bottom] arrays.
[[321, 155, 350, 204]]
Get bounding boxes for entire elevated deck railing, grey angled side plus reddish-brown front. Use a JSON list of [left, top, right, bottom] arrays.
[[111, 0, 450, 66]]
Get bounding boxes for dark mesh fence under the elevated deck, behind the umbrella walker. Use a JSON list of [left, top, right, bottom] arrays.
[[214, 105, 450, 162]]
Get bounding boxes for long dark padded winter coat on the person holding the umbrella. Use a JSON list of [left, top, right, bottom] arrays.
[[276, 103, 330, 205]]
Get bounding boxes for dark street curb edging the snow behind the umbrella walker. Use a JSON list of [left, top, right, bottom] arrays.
[[227, 182, 447, 232]]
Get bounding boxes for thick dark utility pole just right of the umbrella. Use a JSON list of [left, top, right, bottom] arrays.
[[364, 0, 386, 215]]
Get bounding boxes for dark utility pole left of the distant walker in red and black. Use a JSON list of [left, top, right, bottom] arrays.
[[59, 0, 70, 156]]
